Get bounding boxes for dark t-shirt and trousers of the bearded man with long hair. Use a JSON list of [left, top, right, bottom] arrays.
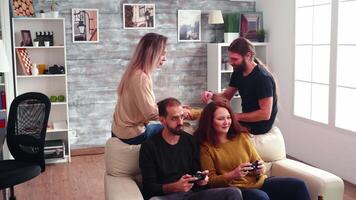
[[229, 65, 278, 135]]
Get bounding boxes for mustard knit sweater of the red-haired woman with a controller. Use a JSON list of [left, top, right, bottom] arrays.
[[200, 133, 267, 188]]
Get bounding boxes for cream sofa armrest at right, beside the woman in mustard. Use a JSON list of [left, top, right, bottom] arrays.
[[271, 159, 344, 200]]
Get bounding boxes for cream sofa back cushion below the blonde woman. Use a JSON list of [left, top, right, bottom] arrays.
[[105, 137, 141, 176]]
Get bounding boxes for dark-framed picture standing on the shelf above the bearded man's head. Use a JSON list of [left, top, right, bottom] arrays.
[[240, 12, 263, 42]]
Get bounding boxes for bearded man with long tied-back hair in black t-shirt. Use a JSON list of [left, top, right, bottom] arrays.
[[201, 38, 278, 135]]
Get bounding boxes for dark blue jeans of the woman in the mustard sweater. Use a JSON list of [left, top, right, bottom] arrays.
[[241, 177, 310, 200]]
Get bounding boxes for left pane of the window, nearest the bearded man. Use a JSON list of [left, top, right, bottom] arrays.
[[294, 0, 331, 123]]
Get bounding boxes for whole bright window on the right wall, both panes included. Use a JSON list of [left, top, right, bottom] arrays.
[[294, 0, 356, 131]]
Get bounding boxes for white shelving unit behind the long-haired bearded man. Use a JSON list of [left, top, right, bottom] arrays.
[[207, 42, 268, 112]]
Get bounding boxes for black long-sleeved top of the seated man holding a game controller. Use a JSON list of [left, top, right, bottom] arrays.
[[139, 133, 200, 198]]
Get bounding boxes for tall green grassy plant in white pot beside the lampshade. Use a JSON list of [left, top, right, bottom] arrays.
[[224, 13, 240, 43]]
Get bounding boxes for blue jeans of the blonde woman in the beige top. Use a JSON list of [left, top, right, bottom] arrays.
[[119, 124, 164, 145]]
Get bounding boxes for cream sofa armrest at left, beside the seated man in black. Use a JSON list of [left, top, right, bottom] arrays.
[[104, 174, 143, 200]]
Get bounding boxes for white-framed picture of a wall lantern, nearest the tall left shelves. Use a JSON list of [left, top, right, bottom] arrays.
[[72, 8, 99, 43]]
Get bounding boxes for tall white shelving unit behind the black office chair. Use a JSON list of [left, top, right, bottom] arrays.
[[12, 18, 70, 163]]
